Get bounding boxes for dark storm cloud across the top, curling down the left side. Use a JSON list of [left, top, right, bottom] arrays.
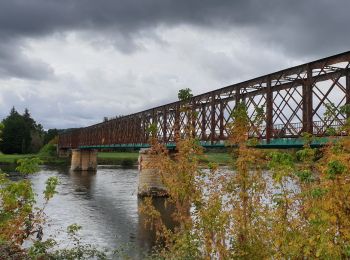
[[0, 0, 350, 78]]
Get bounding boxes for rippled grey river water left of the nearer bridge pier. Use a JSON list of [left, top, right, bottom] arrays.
[[1, 166, 170, 259]]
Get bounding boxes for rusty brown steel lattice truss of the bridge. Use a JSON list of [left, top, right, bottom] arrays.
[[59, 52, 350, 149]]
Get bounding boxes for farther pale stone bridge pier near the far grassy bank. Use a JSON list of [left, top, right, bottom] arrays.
[[71, 149, 97, 171]]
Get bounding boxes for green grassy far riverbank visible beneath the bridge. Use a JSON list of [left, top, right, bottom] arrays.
[[0, 152, 230, 166]]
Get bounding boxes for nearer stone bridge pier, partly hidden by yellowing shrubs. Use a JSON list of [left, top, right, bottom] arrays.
[[138, 149, 168, 197]]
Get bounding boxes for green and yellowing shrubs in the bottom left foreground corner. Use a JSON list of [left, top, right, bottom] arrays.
[[0, 158, 107, 260]]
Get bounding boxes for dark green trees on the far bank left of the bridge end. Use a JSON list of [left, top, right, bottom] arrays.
[[0, 107, 60, 154]]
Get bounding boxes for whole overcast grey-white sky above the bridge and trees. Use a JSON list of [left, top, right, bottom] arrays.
[[0, 0, 350, 129]]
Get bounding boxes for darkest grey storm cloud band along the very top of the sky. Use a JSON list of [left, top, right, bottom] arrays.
[[0, 0, 350, 49]]
